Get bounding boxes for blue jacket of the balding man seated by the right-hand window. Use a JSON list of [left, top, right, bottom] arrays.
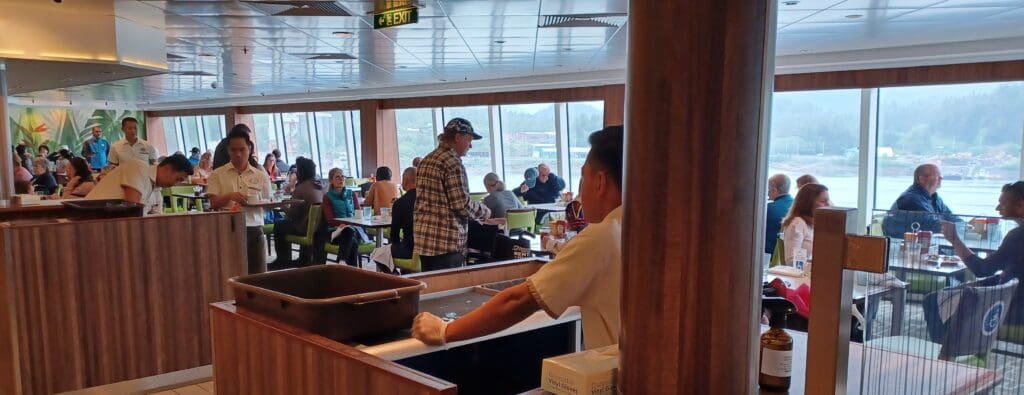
[[882, 184, 962, 238]]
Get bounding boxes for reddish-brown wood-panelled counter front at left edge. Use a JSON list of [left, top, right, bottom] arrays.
[[0, 213, 246, 394]]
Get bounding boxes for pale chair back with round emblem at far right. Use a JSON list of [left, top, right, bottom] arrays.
[[939, 276, 1019, 359]]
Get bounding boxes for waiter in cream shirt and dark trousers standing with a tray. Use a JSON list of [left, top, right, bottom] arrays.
[[207, 128, 273, 274]]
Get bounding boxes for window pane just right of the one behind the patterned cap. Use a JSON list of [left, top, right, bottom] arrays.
[[499, 103, 558, 188]]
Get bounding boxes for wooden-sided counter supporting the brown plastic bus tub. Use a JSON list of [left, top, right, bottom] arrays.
[[210, 259, 582, 395]]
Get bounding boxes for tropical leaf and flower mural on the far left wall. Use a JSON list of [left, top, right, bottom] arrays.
[[8, 104, 145, 155]]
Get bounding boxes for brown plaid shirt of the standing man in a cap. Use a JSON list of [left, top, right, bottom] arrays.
[[413, 146, 490, 257]]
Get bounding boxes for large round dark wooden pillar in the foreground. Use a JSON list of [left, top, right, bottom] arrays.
[[620, 0, 775, 394]]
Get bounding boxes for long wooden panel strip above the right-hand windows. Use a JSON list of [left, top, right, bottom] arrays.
[[775, 60, 1024, 92]]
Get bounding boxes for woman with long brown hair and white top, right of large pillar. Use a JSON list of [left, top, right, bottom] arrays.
[[782, 184, 831, 266]]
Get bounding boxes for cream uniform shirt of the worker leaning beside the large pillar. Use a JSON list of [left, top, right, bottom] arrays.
[[528, 206, 623, 349]]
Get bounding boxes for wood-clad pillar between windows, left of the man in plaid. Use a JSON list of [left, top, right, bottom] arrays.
[[359, 100, 401, 177]]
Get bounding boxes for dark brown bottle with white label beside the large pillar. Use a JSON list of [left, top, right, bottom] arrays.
[[758, 298, 797, 391]]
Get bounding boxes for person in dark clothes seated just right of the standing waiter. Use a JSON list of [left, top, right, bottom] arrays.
[[264, 157, 324, 270]]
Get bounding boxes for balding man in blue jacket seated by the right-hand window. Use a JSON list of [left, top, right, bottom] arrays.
[[882, 164, 963, 238]]
